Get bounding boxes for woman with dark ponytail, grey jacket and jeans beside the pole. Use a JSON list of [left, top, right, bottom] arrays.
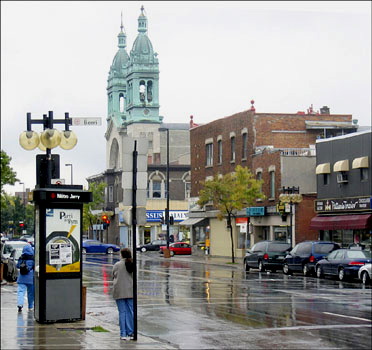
[[112, 248, 134, 340]]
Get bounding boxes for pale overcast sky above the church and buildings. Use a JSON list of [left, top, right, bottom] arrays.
[[1, 1, 371, 193]]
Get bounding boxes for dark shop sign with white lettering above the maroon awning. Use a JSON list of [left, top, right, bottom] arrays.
[[314, 197, 372, 212]]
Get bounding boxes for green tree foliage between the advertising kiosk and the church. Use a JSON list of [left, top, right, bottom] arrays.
[[83, 182, 107, 237]]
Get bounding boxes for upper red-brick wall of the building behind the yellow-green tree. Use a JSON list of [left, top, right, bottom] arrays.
[[190, 111, 352, 197]]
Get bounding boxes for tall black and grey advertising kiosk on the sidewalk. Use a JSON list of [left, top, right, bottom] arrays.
[[33, 185, 92, 323]]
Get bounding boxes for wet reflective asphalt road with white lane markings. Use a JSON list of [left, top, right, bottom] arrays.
[[83, 252, 372, 349]]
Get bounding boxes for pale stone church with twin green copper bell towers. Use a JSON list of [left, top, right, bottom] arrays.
[[87, 6, 191, 246]]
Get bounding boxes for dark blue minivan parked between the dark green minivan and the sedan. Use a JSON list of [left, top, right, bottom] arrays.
[[283, 241, 340, 276]]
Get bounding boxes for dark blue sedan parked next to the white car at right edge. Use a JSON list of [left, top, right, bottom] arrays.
[[315, 249, 372, 281]]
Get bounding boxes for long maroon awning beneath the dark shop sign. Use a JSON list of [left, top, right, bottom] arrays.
[[310, 214, 372, 230]]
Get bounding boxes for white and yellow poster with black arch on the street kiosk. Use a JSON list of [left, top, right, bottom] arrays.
[[46, 208, 81, 273]]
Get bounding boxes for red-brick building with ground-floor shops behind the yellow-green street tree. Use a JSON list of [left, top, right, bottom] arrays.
[[189, 101, 358, 256]]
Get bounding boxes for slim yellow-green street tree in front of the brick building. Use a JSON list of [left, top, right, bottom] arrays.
[[198, 165, 264, 263]]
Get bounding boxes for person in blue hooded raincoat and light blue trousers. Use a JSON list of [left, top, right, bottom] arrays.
[[17, 244, 35, 312]]
